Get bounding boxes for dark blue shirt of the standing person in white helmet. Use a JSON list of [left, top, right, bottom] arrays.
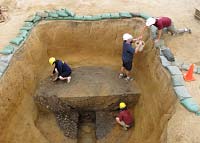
[[122, 42, 135, 62]]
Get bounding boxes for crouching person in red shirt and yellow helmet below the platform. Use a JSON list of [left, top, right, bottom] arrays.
[[116, 102, 133, 130]]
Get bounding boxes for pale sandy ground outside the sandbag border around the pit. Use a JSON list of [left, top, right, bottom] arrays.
[[0, 0, 200, 143]]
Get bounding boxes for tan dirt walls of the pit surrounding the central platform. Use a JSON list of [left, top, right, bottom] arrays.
[[0, 19, 175, 143]]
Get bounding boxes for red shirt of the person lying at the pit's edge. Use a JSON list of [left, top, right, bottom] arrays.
[[154, 17, 172, 30]]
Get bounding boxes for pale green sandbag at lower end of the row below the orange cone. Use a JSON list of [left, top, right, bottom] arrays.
[[181, 97, 200, 113]]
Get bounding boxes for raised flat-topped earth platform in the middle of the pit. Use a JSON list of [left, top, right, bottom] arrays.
[[36, 66, 140, 110]]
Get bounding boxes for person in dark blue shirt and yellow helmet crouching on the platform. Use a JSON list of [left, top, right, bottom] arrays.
[[49, 57, 72, 83]]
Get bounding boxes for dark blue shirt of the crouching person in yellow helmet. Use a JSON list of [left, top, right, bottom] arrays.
[[53, 60, 72, 76]]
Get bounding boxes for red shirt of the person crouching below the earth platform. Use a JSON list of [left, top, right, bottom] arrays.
[[118, 110, 133, 125]]
